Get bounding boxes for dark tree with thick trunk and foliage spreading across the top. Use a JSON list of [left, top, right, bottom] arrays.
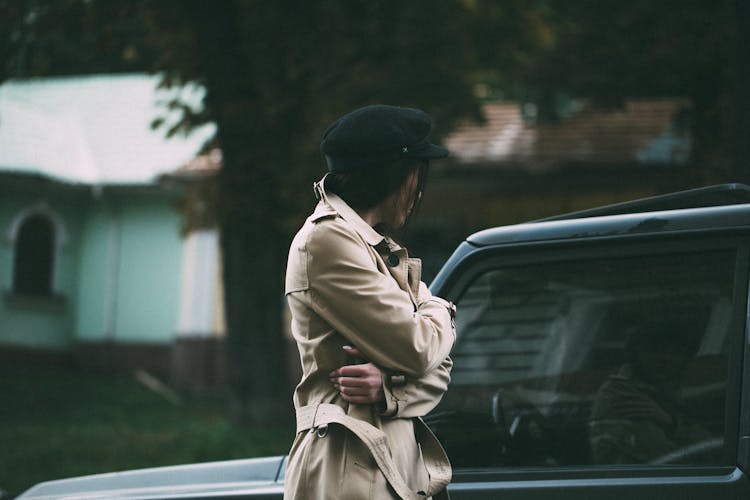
[[0, 0, 747, 422]]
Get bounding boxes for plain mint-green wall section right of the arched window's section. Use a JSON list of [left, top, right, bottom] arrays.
[[76, 194, 182, 343]]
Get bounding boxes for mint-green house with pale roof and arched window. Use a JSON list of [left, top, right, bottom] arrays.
[[0, 74, 224, 388]]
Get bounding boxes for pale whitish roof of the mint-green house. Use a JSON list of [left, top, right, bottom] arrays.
[[0, 74, 215, 185]]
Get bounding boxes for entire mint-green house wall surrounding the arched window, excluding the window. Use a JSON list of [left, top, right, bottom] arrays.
[[0, 178, 183, 350]]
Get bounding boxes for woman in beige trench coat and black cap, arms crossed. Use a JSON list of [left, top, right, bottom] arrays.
[[285, 105, 455, 499]]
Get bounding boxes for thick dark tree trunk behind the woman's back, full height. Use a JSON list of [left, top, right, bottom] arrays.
[[185, 0, 293, 424]]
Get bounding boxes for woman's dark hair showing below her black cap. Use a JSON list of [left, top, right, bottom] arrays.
[[324, 158, 428, 211]]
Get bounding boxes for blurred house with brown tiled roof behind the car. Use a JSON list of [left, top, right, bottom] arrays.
[[432, 98, 692, 223]]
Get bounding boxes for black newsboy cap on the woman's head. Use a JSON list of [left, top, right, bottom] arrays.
[[320, 104, 448, 172]]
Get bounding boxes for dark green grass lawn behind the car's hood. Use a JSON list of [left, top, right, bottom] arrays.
[[0, 363, 293, 496]]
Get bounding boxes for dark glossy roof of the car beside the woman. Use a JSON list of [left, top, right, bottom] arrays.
[[466, 184, 750, 247]]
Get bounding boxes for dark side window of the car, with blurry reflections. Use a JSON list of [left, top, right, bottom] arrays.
[[428, 251, 734, 467]]
